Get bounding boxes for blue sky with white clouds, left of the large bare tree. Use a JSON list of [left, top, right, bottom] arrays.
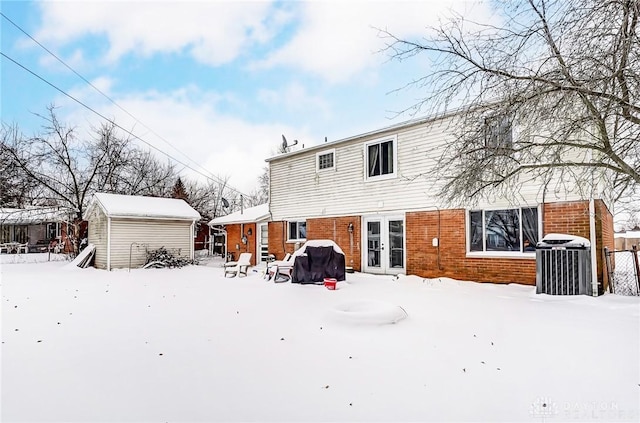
[[0, 0, 490, 193]]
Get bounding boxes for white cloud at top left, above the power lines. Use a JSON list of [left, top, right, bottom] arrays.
[[36, 0, 279, 65]]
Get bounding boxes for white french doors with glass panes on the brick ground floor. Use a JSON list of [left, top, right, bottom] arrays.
[[363, 216, 405, 274]]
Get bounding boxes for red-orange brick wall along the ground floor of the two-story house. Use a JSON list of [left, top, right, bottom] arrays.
[[262, 200, 613, 286]]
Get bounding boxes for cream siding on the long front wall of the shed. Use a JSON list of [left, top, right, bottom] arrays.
[[110, 218, 193, 269]]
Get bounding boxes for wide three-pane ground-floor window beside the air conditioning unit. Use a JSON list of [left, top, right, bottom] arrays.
[[469, 207, 539, 253]]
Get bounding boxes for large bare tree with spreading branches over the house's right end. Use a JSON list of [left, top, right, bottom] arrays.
[[380, 0, 640, 203]]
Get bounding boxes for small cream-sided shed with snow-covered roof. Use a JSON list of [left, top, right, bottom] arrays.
[[86, 193, 200, 270]]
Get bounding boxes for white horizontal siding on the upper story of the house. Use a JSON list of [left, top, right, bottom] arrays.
[[269, 118, 579, 222]]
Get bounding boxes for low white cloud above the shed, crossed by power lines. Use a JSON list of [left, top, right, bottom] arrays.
[[57, 79, 310, 193]]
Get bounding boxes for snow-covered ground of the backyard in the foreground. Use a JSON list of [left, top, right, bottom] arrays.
[[0, 255, 640, 422]]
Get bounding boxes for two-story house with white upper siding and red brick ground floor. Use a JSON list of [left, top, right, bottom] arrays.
[[267, 111, 613, 289]]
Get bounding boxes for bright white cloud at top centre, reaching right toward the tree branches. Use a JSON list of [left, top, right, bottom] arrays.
[[254, 0, 487, 82]]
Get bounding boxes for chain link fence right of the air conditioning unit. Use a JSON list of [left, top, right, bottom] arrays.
[[604, 245, 640, 296]]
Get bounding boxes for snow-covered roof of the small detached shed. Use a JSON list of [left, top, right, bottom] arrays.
[[89, 192, 200, 220]]
